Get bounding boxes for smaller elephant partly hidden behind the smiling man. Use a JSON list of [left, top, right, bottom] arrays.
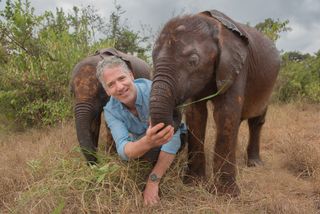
[[70, 48, 151, 165]]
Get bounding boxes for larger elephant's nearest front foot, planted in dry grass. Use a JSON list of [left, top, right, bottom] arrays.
[[208, 183, 241, 198]]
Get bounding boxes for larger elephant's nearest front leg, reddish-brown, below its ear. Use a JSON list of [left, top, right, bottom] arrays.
[[211, 100, 242, 196]]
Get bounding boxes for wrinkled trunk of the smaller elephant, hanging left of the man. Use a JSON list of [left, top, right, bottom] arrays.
[[74, 102, 97, 164]]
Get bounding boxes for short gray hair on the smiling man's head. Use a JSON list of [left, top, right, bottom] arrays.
[[96, 56, 131, 89]]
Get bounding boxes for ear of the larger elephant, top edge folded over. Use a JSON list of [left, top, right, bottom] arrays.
[[202, 10, 249, 93]]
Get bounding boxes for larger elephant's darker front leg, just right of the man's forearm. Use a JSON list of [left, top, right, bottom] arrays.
[[186, 102, 208, 177]]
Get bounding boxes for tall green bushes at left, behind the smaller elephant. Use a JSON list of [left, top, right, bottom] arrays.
[[0, 0, 151, 127]]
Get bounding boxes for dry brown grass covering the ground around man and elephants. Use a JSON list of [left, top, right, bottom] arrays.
[[0, 104, 320, 214]]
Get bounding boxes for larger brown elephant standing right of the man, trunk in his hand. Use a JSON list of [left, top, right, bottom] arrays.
[[150, 10, 280, 196]]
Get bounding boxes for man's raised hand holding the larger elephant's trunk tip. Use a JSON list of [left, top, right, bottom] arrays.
[[146, 123, 174, 147]]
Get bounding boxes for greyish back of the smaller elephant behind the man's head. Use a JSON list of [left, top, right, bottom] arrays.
[[94, 48, 151, 79]]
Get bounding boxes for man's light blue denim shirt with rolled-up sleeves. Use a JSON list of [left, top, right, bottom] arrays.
[[103, 78, 181, 160]]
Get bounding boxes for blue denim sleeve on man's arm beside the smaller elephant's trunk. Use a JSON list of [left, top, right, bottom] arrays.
[[104, 108, 129, 161]]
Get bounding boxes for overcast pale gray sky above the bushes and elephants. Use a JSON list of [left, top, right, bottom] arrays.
[[0, 0, 320, 54]]
